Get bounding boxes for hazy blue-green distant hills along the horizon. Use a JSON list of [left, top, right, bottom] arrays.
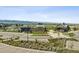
[[0, 20, 79, 25]]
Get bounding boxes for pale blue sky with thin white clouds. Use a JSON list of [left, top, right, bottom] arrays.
[[0, 6, 79, 23]]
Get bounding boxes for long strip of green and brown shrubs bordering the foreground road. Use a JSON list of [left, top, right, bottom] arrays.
[[0, 38, 79, 53]]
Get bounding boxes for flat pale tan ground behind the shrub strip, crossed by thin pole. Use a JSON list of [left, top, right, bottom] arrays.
[[0, 32, 50, 42]]
